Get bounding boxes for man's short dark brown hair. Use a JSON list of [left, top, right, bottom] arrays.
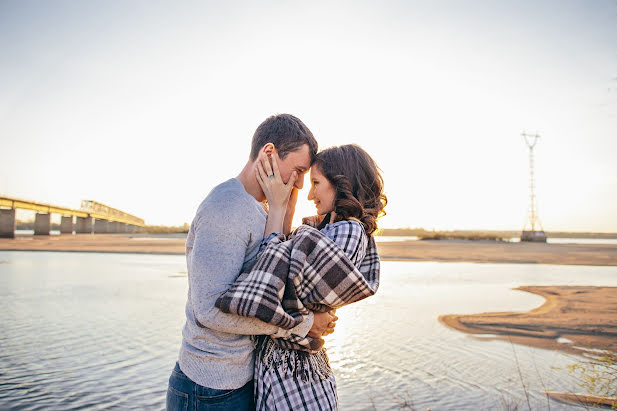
[[251, 114, 318, 164]]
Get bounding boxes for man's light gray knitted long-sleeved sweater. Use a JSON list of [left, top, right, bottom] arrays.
[[179, 178, 313, 389]]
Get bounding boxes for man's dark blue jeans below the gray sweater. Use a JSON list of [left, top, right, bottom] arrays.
[[166, 363, 255, 411]]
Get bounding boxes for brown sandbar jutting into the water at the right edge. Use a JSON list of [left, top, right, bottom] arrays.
[[439, 286, 617, 354]]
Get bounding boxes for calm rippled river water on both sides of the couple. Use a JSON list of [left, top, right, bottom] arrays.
[[0, 252, 617, 410]]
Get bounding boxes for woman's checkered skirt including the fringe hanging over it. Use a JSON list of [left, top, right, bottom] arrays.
[[254, 337, 338, 411]]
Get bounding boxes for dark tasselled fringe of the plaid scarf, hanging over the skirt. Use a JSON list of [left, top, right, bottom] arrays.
[[253, 337, 332, 382]]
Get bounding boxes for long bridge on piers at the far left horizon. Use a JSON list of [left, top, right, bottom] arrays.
[[0, 197, 145, 238]]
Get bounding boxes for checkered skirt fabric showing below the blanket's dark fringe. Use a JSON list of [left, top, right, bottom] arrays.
[[254, 340, 338, 411]]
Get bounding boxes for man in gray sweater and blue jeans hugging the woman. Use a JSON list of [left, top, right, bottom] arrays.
[[167, 114, 335, 410]]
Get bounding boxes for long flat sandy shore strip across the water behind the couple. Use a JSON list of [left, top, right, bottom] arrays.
[[0, 234, 617, 265]]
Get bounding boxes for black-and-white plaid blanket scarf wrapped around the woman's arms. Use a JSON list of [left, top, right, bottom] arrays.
[[216, 225, 379, 353]]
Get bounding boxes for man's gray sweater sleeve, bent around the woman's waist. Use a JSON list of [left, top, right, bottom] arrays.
[[187, 202, 313, 337]]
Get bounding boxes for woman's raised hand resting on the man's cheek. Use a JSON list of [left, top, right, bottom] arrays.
[[255, 153, 298, 216]]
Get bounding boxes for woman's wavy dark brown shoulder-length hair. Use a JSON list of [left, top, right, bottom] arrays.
[[313, 144, 388, 235]]
